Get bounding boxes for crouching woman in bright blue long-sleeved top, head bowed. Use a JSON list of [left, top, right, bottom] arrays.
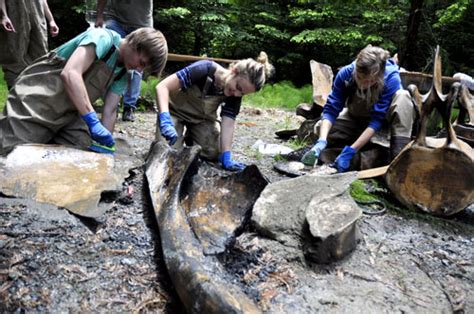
[[301, 45, 415, 172]]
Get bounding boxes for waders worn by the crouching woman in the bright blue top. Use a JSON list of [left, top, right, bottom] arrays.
[[315, 90, 416, 159]]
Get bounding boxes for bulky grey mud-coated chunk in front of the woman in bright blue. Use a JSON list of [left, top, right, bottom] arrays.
[[252, 172, 362, 263]]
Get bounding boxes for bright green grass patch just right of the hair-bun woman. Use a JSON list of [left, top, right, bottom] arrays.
[[242, 81, 313, 109]]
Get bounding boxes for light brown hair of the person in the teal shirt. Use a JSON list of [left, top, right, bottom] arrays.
[[125, 27, 168, 76]]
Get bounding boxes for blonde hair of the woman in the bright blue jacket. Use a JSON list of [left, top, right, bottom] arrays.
[[353, 45, 390, 102]]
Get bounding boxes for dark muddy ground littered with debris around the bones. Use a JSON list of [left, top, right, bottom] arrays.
[[0, 109, 474, 313]]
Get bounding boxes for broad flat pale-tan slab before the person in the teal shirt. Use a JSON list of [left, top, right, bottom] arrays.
[[0, 144, 138, 218]]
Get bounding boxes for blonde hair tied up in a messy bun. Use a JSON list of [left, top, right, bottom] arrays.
[[230, 51, 275, 91]]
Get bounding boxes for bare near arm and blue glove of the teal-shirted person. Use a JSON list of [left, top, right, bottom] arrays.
[[61, 45, 115, 147]]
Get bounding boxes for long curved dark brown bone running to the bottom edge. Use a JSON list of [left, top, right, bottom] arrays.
[[146, 143, 260, 313]]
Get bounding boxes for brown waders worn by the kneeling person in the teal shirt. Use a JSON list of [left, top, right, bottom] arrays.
[[0, 47, 123, 154]]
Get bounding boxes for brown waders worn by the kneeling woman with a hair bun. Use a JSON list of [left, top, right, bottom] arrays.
[[156, 86, 225, 161]]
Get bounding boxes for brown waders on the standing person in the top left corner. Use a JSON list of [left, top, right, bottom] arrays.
[[0, 0, 48, 88]]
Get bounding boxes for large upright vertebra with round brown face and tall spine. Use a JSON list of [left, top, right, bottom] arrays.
[[385, 47, 474, 216]]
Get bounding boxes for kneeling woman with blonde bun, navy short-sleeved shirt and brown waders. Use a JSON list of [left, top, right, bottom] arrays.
[[156, 52, 273, 170]]
